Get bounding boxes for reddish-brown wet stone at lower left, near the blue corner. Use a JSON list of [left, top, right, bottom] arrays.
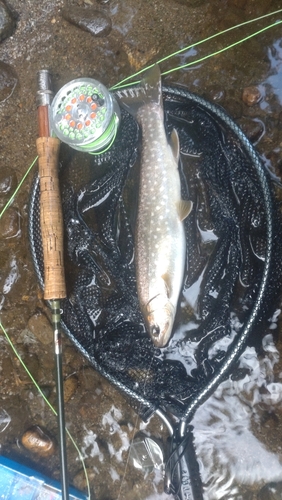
[[21, 425, 57, 457]]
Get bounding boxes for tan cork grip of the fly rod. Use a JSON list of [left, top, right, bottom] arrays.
[[36, 137, 66, 300]]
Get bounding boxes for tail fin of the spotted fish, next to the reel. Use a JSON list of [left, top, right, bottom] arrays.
[[116, 64, 163, 116]]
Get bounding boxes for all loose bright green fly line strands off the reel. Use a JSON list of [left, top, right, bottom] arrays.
[[0, 5, 282, 500]]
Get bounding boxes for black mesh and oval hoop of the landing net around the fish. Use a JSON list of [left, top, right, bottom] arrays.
[[29, 87, 282, 419]]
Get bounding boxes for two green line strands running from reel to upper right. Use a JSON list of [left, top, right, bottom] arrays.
[[110, 9, 282, 90]]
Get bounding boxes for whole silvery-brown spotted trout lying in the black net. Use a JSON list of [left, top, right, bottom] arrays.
[[117, 65, 193, 348]]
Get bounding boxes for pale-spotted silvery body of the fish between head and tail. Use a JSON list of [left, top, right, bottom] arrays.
[[136, 104, 185, 318]]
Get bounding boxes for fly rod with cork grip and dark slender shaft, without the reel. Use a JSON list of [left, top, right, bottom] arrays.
[[36, 70, 69, 500]]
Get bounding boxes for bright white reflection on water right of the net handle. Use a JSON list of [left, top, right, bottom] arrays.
[[192, 334, 282, 500]]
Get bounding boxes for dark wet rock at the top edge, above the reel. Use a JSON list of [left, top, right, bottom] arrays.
[[62, 6, 112, 37]]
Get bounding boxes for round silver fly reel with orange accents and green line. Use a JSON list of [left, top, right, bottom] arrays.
[[50, 78, 120, 154]]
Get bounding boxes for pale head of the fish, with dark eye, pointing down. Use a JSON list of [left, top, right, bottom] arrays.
[[145, 295, 175, 347]]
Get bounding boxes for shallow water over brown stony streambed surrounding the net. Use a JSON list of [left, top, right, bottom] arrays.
[[0, 0, 282, 500]]
